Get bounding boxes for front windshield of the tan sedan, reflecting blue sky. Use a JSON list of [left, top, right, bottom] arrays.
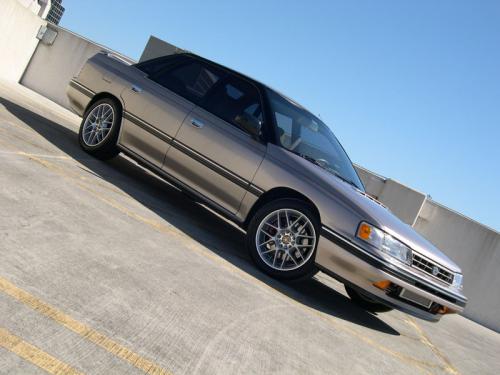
[[268, 90, 364, 191]]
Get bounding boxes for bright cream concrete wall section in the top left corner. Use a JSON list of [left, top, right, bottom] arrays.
[[0, 0, 46, 82]]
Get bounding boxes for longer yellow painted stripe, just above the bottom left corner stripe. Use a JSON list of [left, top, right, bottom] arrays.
[[0, 277, 169, 375]]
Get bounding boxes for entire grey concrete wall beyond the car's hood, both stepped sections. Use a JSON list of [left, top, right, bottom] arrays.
[[356, 166, 500, 332]]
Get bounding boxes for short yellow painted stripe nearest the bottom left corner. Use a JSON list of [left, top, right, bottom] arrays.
[[0, 328, 82, 375]]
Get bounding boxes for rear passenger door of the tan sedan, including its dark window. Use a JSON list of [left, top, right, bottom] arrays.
[[119, 55, 219, 168]]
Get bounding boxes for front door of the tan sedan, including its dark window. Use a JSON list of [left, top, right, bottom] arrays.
[[163, 73, 266, 214]]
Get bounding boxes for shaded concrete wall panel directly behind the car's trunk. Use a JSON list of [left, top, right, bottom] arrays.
[[21, 25, 134, 108]]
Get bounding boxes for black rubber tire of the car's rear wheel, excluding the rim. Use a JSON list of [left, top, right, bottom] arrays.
[[78, 98, 122, 159]]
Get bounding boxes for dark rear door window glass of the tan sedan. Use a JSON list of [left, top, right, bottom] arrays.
[[150, 59, 222, 103]]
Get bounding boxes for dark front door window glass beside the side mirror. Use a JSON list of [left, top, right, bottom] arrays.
[[202, 76, 262, 134]]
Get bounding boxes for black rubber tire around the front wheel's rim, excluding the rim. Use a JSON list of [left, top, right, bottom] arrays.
[[246, 199, 320, 280]]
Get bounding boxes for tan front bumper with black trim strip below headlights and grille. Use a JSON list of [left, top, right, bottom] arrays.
[[316, 226, 467, 321]]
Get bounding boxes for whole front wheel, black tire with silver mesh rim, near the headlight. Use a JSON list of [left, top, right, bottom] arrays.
[[246, 199, 320, 280]]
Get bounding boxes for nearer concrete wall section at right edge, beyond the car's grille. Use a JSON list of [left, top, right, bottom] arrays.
[[414, 200, 500, 332]]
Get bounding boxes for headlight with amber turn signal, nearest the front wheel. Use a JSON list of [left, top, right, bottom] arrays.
[[357, 222, 412, 265]]
